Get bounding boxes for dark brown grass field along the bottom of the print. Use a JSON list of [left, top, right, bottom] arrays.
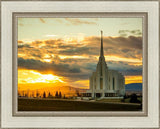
[[18, 98, 142, 111]]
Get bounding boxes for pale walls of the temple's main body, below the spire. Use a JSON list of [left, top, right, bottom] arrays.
[[89, 70, 125, 98]]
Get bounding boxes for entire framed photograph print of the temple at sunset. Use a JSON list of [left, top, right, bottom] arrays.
[[17, 17, 143, 112]]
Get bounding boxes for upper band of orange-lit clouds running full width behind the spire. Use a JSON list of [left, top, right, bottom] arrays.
[[18, 36, 142, 60]]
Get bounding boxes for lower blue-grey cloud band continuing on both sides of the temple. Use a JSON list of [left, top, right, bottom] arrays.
[[18, 57, 142, 81]]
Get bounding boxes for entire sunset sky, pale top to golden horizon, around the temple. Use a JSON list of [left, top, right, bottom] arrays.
[[18, 18, 142, 90]]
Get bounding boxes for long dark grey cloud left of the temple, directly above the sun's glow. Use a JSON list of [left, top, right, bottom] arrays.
[[18, 58, 88, 80]]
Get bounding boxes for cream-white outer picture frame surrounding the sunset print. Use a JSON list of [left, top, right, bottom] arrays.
[[1, 1, 159, 128]]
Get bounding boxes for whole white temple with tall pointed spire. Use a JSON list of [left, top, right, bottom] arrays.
[[85, 31, 125, 98]]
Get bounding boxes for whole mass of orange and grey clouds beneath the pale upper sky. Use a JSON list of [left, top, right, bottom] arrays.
[[18, 35, 142, 88]]
